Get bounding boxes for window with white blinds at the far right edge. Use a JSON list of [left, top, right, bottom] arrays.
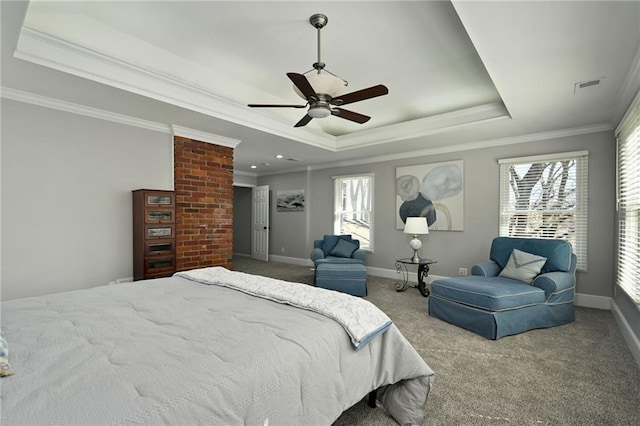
[[616, 93, 640, 307]]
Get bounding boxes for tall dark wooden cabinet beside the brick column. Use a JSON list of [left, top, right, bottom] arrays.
[[133, 189, 176, 281]]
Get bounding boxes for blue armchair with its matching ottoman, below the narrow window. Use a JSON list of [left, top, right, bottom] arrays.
[[310, 235, 367, 296]]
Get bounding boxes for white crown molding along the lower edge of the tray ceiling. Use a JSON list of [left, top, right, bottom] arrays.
[[14, 26, 520, 152]]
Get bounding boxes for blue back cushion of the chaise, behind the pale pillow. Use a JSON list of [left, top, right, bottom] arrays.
[[489, 237, 572, 273]]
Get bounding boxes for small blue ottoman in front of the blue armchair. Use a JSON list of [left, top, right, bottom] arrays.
[[315, 262, 367, 296]]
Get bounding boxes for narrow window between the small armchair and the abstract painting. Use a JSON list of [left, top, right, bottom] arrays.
[[333, 174, 373, 251]]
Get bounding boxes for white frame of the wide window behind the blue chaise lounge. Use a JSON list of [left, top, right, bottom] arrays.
[[498, 151, 589, 271]]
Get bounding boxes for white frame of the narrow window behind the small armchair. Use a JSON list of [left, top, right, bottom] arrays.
[[333, 173, 375, 252]]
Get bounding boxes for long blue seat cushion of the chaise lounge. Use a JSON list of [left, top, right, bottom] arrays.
[[431, 276, 545, 311]]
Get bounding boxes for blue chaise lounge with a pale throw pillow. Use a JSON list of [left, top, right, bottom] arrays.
[[429, 237, 577, 340]]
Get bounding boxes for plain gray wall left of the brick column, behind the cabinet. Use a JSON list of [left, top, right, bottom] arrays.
[[0, 99, 173, 300]]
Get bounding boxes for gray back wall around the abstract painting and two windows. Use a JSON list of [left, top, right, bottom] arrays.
[[258, 132, 615, 297]]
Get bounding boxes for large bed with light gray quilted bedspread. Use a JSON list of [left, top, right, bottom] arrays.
[[0, 268, 433, 425]]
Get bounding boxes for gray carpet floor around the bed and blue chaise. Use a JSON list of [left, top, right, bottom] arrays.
[[234, 257, 640, 426]]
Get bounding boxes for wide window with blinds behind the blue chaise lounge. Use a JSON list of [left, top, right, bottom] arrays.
[[499, 151, 589, 271]]
